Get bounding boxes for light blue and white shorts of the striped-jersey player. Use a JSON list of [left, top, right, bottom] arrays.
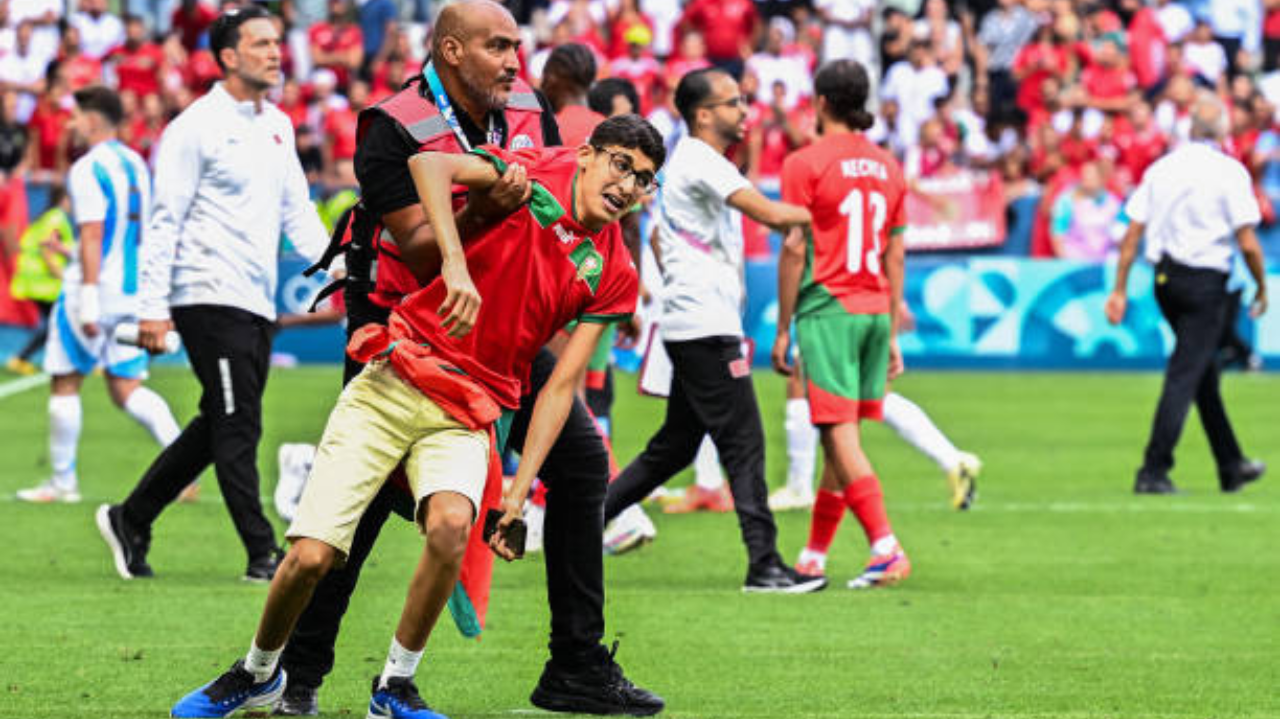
[[45, 293, 147, 380]]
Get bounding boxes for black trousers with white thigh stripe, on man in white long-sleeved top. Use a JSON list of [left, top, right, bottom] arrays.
[[124, 304, 276, 560]]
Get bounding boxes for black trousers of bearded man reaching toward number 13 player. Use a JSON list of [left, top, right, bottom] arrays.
[[604, 336, 781, 567]]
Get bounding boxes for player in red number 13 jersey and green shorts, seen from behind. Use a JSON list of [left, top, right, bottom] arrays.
[[773, 60, 911, 589]]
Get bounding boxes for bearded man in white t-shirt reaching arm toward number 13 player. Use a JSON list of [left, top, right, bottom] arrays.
[[604, 68, 827, 594]]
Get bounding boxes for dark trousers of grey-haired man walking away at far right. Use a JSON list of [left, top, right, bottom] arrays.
[[1142, 260, 1243, 476]]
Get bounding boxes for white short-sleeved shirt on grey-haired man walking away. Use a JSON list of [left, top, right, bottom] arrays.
[[1125, 142, 1262, 273]]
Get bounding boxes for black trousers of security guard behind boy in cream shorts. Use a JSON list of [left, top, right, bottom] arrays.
[[280, 293, 609, 687]]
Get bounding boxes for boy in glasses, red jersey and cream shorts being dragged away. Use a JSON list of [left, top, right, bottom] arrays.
[[172, 115, 666, 719]]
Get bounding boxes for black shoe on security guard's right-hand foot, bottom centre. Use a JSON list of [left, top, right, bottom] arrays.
[[529, 642, 667, 716]]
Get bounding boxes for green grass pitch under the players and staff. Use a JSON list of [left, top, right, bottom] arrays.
[[0, 367, 1280, 719]]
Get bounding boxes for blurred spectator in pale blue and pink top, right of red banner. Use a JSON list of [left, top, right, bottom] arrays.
[[1050, 162, 1120, 261]]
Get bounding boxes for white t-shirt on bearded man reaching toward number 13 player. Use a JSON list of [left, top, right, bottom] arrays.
[[655, 136, 751, 342]]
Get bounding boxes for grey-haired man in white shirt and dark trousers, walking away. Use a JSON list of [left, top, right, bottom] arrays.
[[1106, 97, 1267, 494]]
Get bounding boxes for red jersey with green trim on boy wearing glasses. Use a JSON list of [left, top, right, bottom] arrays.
[[384, 145, 639, 408]]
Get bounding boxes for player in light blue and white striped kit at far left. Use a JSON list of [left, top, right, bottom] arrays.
[[18, 87, 178, 503]]
